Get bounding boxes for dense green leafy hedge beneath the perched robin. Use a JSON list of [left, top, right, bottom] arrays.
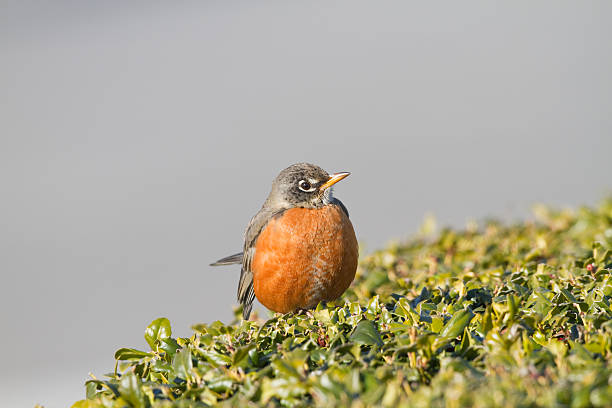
[[73, 199, 612, 408]]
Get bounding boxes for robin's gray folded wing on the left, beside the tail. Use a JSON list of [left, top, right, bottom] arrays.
[[238, 207, 284, 320]]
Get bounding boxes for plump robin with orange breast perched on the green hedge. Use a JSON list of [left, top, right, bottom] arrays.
[[211, 163, 359, 319]]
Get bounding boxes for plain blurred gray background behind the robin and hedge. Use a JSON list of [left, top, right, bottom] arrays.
[[0, 1, 612, 407]]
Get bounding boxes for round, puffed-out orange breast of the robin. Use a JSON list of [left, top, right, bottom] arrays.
[[251, 205, 359, 313]]
